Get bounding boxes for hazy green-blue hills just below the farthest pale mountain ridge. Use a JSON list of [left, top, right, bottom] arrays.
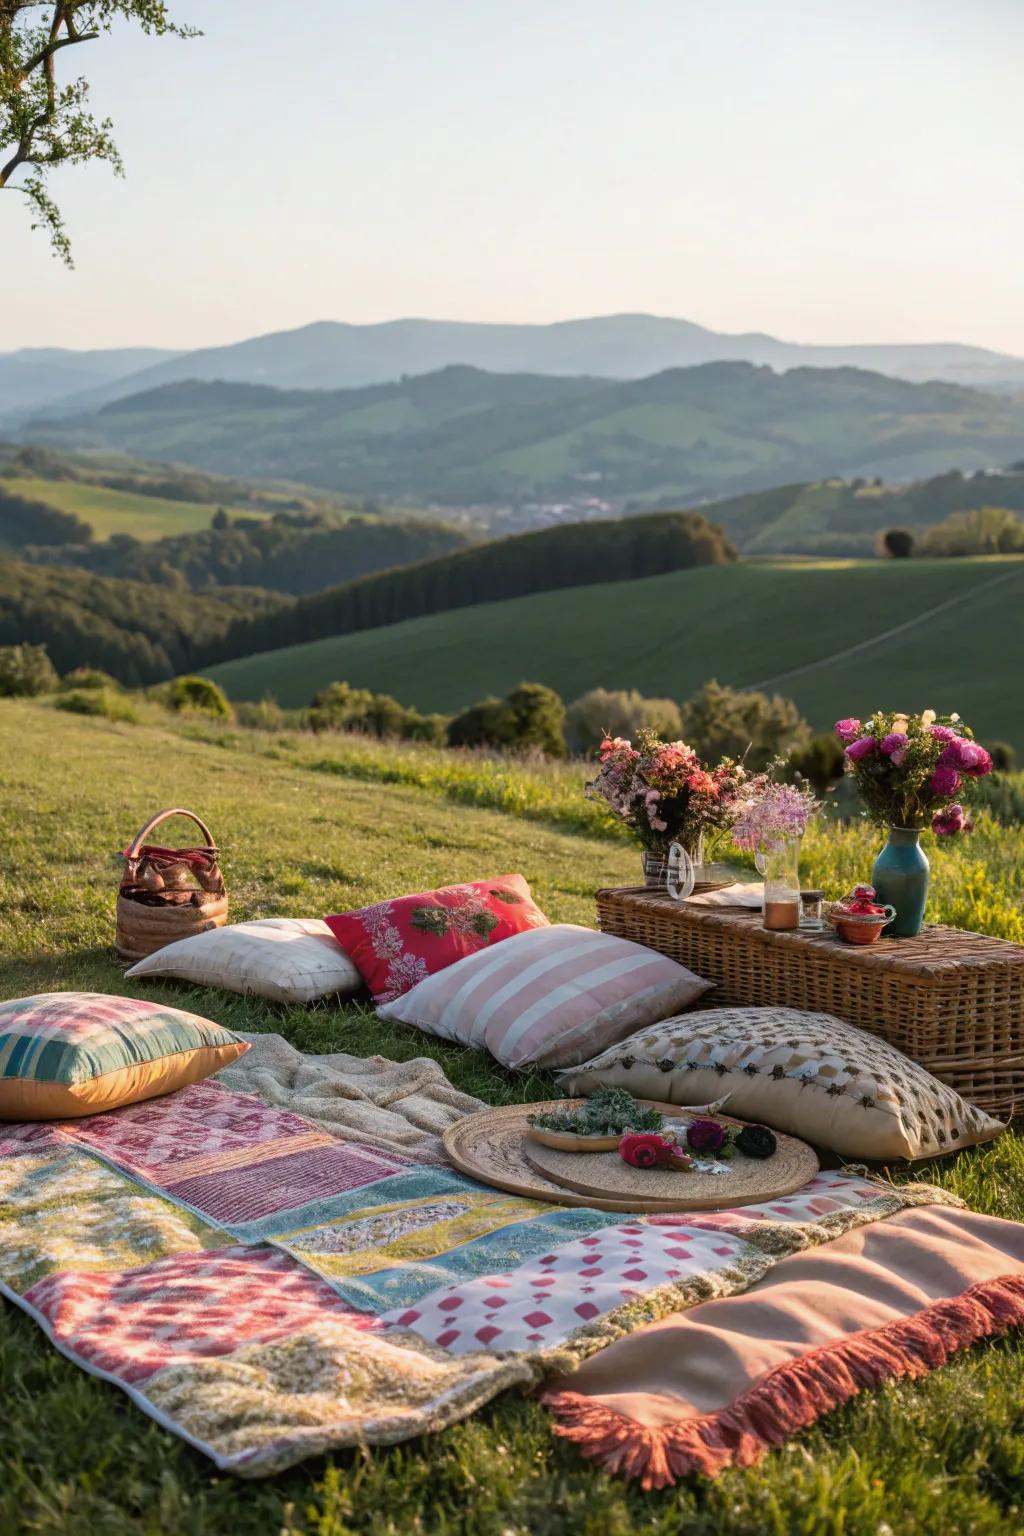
[[28, 362, 1024, 516]]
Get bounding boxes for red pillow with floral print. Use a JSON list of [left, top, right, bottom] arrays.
[[325, 874, 548, 1003]]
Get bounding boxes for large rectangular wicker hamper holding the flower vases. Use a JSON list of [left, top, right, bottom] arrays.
[[597, 886, 1024, 1120]]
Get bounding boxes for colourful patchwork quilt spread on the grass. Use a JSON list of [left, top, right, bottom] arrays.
[[0, 1081, 960, 1476]]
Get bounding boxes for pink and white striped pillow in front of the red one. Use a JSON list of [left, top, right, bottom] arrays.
[[378, 923, 712, 1066]]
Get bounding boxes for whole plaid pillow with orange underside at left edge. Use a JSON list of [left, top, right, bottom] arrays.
[[0, 992, 249, 1120]]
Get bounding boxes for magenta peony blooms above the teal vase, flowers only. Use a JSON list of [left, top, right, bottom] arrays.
[[835, 710, 992, 837]]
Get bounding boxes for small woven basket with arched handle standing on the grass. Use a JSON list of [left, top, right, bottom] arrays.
[[115, 806, 227, 960]]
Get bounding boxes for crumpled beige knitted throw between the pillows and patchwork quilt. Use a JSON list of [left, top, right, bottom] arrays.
[[216, 1034, 485, 1163]]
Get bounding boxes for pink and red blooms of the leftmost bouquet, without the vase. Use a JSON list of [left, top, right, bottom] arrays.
[[586, 731, 749, 852]]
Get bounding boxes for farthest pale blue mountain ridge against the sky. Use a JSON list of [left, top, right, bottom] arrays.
[[0, 315, 1024, 419]]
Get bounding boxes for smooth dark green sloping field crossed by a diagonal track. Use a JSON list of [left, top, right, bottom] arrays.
[[209, 558, 1024, 748]]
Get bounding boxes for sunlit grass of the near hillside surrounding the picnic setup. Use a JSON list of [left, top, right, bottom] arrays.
[[0, 700, 1024, 1536]]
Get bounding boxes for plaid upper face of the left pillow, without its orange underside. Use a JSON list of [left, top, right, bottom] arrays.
[[0, 992, 241, 1086]]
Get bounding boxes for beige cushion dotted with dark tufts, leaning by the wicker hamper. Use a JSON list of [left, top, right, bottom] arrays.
[[560, 1008, 1003, 1160]]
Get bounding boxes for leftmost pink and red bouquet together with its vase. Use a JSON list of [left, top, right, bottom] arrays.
[[586, 731, 749, 895]]
